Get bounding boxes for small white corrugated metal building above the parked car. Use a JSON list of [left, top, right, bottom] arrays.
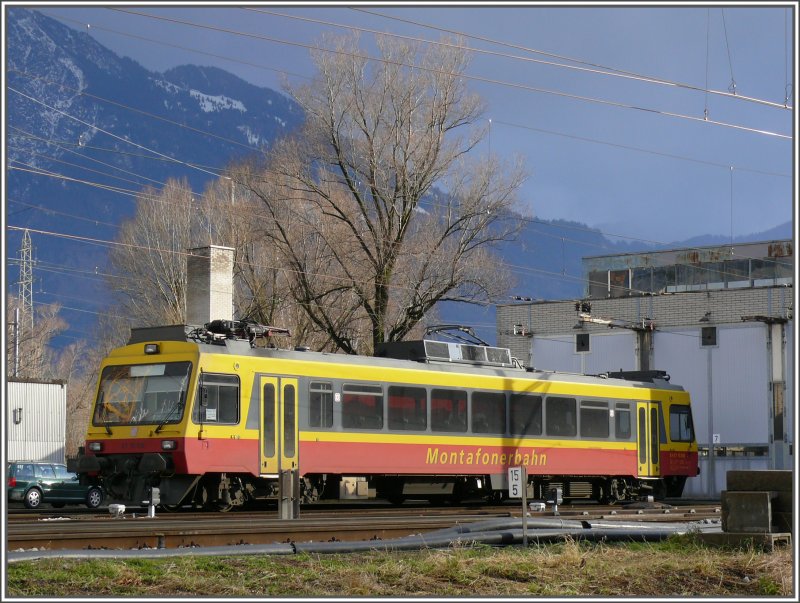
[[6, 381, 67, 463]]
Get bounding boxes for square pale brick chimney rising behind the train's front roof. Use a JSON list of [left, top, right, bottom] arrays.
[[186, 245, 234, 326]]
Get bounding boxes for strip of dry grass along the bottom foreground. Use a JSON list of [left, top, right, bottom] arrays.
[[6, 538, 794, 598]]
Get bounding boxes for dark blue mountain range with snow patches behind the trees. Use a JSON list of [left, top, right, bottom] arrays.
[[6, 8, 792, 350]]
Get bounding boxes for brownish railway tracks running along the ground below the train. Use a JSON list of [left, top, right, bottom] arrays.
[[6, 504, 721, 551]]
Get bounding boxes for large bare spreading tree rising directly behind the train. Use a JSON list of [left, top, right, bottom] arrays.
[[244, 37, 524, 353]]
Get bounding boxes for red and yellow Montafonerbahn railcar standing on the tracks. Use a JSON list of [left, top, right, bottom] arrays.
[[73, 326, 698, 510]]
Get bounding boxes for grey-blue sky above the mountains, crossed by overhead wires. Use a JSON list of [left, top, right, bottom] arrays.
[[36, 3, 796, 243]]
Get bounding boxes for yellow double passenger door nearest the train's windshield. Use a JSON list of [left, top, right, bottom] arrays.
[[259, 377, 298, 476]]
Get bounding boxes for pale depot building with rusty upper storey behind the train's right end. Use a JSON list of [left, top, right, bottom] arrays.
[[497, 240, 795, 498]]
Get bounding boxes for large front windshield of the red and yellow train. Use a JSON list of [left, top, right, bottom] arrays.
[[92, 362, 192, 427]]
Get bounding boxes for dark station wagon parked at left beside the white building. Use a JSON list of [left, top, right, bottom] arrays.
[[7, 461, 104, 509]]
